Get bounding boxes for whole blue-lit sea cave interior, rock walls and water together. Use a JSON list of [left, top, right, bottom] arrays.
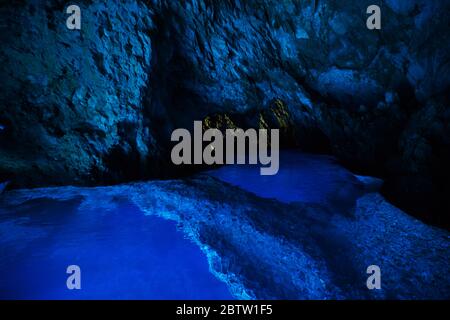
[[0, 0, 450, 300]]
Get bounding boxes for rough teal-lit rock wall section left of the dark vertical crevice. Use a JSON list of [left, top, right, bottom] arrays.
[[0, 1, 158, 186]]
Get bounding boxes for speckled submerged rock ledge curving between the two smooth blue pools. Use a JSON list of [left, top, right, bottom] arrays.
[[0, 175, 450, 299]]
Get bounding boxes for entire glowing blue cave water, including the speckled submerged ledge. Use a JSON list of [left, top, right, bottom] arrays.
[[0, 152, 450, 299]]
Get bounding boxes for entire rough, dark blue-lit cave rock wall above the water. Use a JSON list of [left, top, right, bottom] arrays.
[[0, 0, 450, 225]]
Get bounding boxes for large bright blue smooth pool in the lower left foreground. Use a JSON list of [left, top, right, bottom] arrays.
[[0, 199, 232, 299]]
